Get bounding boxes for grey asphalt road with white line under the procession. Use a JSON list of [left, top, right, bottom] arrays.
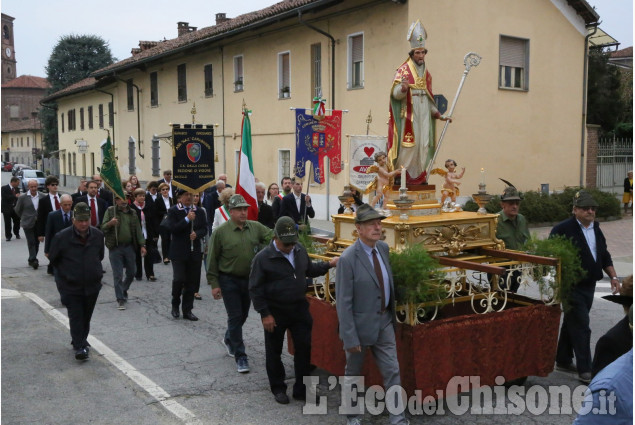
[[0, 173, 632, 425]]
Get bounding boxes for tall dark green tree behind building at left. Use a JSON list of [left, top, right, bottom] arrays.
[[40, 34, 117, 152]]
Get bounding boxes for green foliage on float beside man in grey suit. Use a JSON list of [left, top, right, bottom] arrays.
[[390, 245, 445, 304]]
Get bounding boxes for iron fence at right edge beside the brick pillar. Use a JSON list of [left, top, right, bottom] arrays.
[[596, 137, 633, 193]]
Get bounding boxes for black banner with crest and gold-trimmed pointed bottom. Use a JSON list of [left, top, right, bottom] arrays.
[[172, 124, 216, 192]]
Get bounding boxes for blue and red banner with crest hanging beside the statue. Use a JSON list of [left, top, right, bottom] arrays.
[[293, 109, 342, 184]]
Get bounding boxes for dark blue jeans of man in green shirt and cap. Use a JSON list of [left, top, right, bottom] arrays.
[[218, 273, 251, 361]]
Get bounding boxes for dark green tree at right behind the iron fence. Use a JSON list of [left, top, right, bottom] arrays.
[[587, 49, 633, 134]]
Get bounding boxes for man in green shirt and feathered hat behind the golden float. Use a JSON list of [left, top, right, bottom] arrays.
[[496, 186, 529, 292]]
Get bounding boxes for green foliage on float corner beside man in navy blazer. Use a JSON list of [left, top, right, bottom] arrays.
[[522, 235, 586, 311]]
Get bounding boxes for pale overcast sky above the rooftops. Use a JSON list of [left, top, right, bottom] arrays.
[[2, 0, 633, 77]]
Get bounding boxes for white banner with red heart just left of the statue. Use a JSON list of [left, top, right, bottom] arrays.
[[348, 135, 387, 193]]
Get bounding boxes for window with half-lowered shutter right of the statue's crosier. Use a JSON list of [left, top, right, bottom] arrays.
[[498, 36, 529, 90]]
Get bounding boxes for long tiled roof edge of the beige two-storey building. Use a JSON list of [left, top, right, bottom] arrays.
[[92, 0, 328, 77]]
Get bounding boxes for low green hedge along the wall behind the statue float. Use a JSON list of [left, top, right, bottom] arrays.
[[463, 187, 621, 223]]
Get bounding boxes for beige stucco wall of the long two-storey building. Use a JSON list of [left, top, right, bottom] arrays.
[[53, 0, 584, 218]]
